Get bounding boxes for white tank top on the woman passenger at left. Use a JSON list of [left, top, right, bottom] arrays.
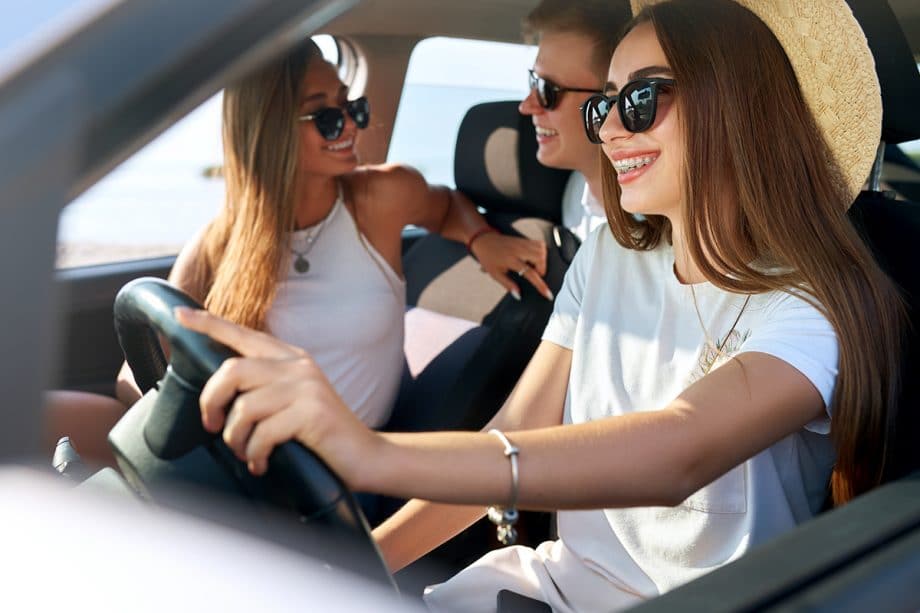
[[266, 190, 406, 428]]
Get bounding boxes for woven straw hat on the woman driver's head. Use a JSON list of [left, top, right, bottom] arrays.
[[630, 0, 882, 198]]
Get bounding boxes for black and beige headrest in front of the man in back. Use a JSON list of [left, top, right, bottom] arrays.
[[454, 101, 570, 223]]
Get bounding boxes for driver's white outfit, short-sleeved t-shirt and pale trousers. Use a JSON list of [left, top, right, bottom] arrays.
[[426, 225, 838, 611]]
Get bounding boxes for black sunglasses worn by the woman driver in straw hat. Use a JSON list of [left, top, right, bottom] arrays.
[[581, 79, 674, 145]]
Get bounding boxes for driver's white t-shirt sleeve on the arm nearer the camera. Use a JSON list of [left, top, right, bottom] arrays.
[[739, 294, 838, 434]]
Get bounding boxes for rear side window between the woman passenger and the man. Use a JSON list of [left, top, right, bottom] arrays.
[[387, 37, 537, 187]]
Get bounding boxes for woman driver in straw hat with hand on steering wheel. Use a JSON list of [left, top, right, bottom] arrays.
[[177, 0, 905, 611]]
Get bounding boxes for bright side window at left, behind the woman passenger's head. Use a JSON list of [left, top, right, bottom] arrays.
[[57, 35, 339, 268]]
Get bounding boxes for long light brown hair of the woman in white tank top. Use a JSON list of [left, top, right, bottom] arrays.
[[186, 40, 322, 329]]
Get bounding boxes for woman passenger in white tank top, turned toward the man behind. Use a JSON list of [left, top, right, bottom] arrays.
[[46, 40, 552, 463]]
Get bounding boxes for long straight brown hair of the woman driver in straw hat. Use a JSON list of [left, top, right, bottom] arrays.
[[603, 0, 905, 504]]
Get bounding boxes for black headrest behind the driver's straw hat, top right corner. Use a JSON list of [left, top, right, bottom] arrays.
[[847, 0, 920, 144]]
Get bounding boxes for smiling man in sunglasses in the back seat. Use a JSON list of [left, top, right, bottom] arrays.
[[519, 0, 630, 240]]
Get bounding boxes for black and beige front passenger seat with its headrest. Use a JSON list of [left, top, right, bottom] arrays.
[[387, 101, 578, 431]]
